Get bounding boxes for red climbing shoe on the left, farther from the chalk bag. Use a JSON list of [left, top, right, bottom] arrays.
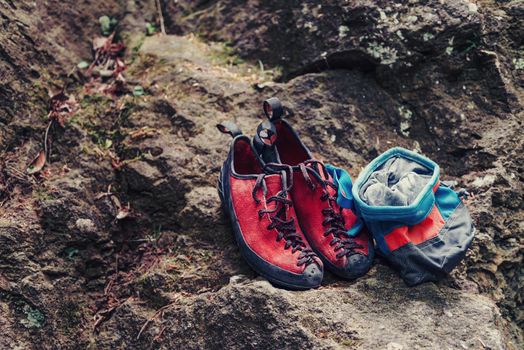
[[217, 122, 323, 289]]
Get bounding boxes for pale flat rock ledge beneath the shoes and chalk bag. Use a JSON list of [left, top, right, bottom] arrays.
[[100, 267, 505, 349]]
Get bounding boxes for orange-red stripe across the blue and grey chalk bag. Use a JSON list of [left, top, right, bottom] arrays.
[[384, 205, 445, 251]]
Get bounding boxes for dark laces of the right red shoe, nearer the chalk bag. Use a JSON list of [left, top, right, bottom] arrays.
[[299, 159, 363, 259]]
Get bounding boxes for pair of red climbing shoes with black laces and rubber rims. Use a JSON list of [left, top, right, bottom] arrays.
[[217, 98, 374, 289]]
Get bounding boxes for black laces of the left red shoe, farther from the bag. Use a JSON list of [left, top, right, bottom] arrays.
[[252, 163, 318, 266]]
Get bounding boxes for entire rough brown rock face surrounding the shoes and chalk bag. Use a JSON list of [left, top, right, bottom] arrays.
[[0, 0, 524, 349]]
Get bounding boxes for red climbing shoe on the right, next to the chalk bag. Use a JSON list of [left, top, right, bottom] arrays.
[[253, 98, 374, 279]]
